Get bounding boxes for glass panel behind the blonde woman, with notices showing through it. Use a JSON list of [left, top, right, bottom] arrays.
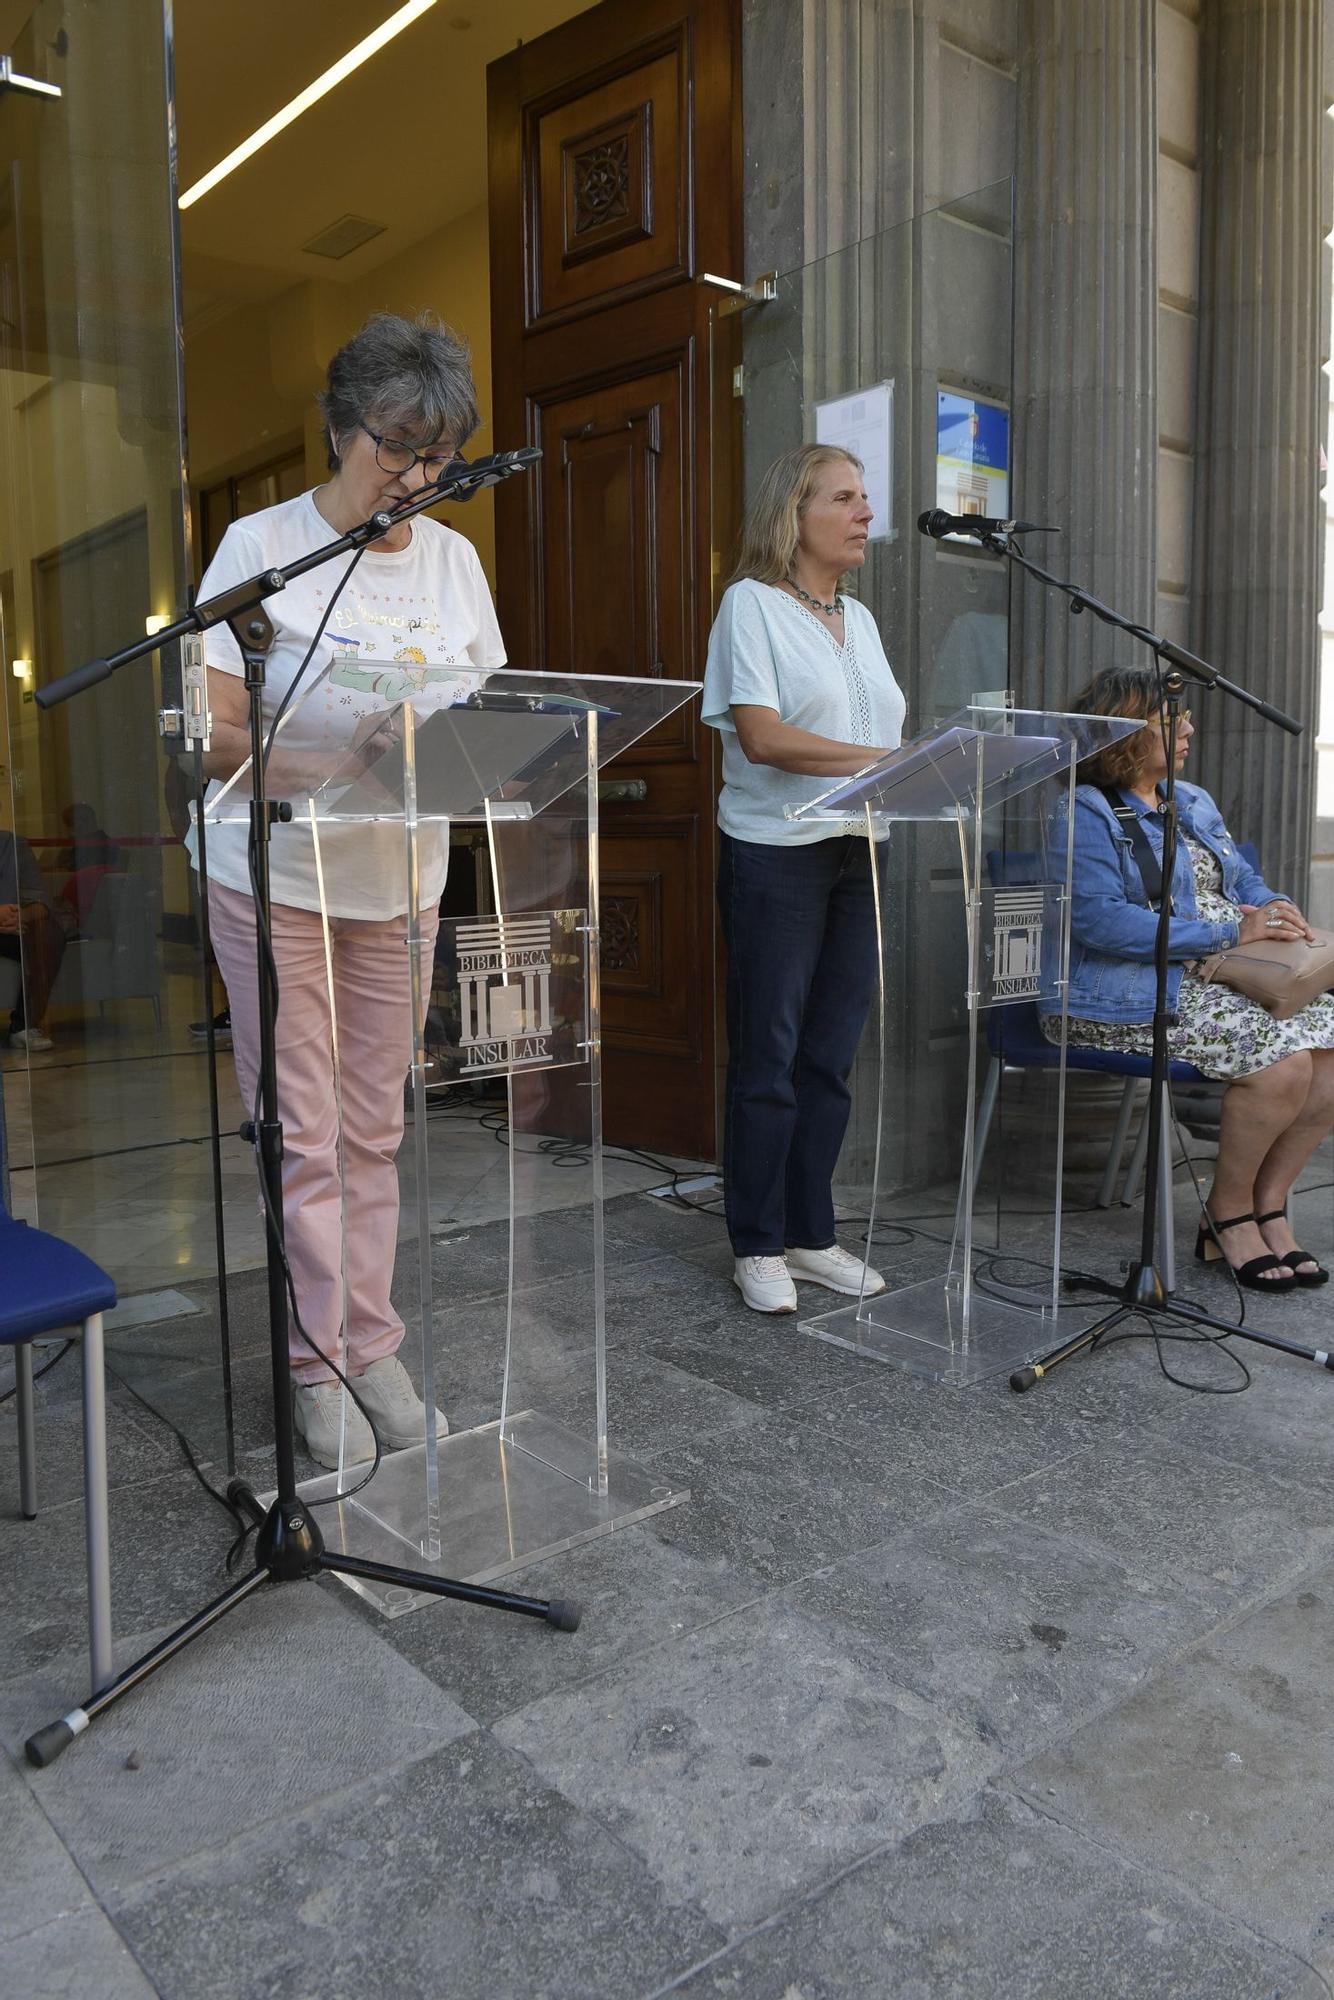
[[710, 182, 1022, 1248]]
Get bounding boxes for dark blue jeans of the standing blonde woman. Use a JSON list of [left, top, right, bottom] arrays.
[[718, 834, 886, 1256]]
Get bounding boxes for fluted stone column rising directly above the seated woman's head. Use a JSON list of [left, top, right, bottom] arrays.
[[1010, 0, 1158, 708]]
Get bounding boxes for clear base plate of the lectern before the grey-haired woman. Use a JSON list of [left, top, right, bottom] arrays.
[[264, 1410, 690, 1618]]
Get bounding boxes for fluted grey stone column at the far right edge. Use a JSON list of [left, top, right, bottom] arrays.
[[1190, 0, 1328, 896]]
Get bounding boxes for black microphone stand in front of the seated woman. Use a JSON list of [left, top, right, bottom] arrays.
[[940, 530, 1334, 1394]]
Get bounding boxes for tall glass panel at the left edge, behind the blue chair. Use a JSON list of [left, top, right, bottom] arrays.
[[0, 11, 234, 1460]]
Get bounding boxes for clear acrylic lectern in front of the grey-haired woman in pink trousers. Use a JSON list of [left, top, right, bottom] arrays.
[[206, 654, 698, 1616]]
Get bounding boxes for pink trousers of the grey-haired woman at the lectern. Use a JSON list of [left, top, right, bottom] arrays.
[[208, 884, 438, 1382]]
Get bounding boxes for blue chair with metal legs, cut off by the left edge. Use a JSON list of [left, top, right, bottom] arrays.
[[0, 1090, 116, 1692]]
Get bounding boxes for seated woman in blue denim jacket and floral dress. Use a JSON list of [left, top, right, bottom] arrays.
[[1044, 668, 1334, 1292]]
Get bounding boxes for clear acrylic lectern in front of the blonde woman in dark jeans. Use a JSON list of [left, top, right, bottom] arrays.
[[794, 700, 1144, 1386]]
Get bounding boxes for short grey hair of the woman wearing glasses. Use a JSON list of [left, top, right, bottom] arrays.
[[316, 312, 482, 472]]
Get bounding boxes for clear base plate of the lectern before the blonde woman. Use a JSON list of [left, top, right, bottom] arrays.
[[798, 1278, 1058, 1388]]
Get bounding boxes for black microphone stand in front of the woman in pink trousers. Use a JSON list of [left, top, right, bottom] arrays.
[[24, 448, 580, 1766]]
